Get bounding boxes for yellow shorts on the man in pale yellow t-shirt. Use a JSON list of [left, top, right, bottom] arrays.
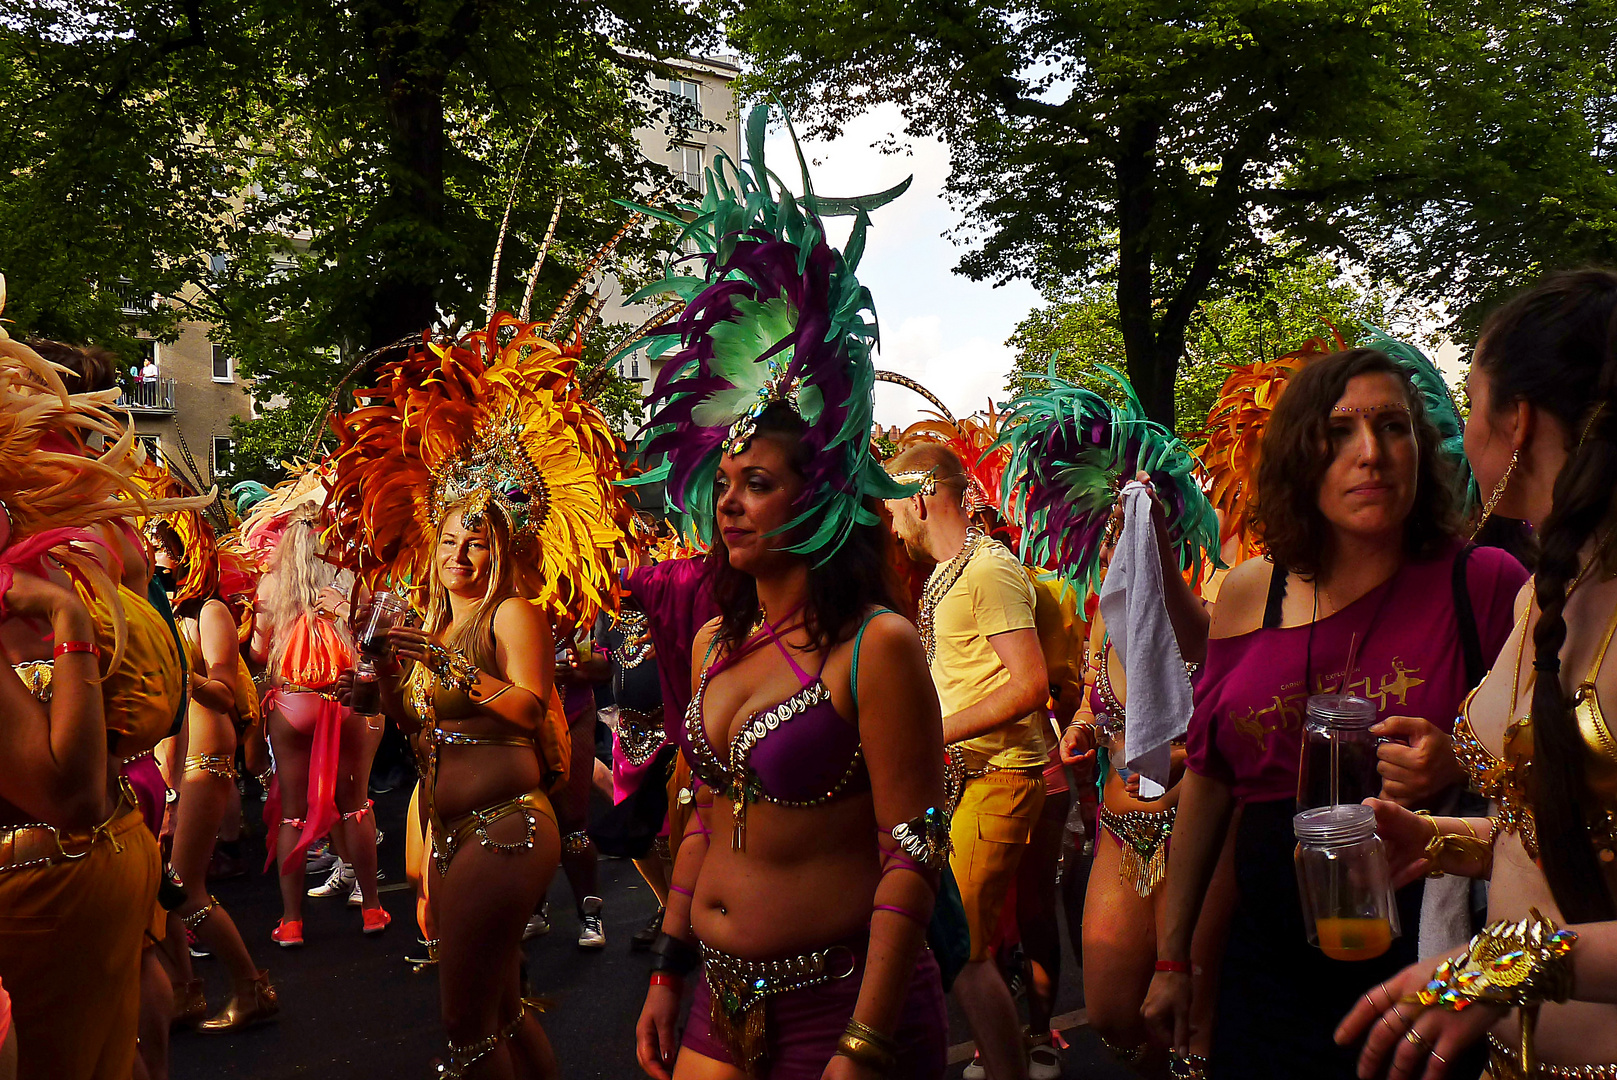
[[949, 771, 1045, 960]]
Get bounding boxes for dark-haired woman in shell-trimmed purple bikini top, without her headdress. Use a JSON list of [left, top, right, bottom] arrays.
[[637, 406, 949, 1080]]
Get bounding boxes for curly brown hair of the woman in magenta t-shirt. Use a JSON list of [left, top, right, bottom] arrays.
[[1250, 349, 1460, 577]]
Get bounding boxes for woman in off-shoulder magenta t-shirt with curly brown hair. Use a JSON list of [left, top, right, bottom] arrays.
[[1145, 349, 1526, 1080]]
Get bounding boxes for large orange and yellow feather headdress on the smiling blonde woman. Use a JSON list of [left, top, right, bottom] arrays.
[[327, 236, 632, 624]]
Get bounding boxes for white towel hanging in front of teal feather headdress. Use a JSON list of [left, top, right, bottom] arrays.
[[1101, 480, 1192, 799]]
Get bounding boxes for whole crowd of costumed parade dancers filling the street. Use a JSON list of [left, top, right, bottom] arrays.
[[0, 108, 1617, 1080]]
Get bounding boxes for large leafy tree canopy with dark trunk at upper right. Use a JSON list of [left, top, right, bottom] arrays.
[[724, 0, 1617, 424]]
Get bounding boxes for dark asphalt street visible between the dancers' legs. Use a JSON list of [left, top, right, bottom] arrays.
[[171, 791, 1134, 1080]]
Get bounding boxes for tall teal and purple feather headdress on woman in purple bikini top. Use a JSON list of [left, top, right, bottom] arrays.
[[620, 105, 914, 561]]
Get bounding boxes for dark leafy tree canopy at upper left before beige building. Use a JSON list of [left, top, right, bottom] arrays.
[[0, 0, 708, 475]]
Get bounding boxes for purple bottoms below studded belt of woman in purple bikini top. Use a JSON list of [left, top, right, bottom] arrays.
[[681, 947, 949, 1080]]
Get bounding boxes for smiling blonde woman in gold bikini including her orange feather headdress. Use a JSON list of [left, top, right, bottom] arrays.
[[327, 271, 627, 1080]]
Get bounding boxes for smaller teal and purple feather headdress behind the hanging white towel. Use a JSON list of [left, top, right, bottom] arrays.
[[996, 365, 1219, 592]]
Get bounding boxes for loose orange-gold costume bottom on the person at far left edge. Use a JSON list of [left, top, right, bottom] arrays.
[[0, 805, 160, 1080]]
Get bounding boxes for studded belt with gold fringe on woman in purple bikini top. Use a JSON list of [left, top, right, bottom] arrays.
[[702, 944, 859, 1077]]
